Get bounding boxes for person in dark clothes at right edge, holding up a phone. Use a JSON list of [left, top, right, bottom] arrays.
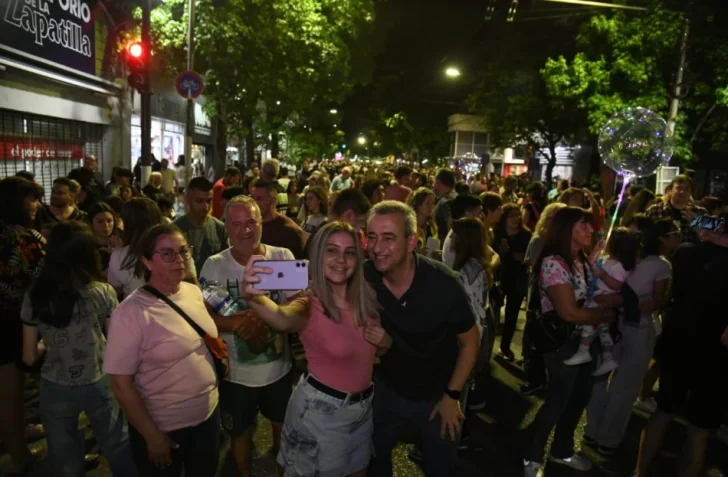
[[634, 215, 728, 477]]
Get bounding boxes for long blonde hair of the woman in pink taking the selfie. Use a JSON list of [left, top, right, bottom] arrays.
[[309, 222, 380, 326]]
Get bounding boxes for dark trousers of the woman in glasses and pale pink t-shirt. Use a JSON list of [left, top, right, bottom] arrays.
[[129, 406, 220, 477]]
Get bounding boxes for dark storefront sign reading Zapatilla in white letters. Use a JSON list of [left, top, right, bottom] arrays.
[[0, 0, 97, 76]]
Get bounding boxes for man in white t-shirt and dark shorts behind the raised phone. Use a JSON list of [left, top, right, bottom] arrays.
[[200, 196, 295, 477]]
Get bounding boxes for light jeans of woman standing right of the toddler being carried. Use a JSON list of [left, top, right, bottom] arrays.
[[585, 323, 656, 449]]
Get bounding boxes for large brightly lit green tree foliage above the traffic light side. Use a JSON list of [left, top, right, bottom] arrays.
[[152, 0, 374, 165]]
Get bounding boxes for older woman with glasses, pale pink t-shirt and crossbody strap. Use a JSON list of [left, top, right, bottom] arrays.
[[104, 224, 220, 477]]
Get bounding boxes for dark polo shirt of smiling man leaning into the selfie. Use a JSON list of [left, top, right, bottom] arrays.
[[364, 254, 475, 401]]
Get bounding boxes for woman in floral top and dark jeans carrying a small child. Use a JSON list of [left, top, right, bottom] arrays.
[[523, 207, 621, 477]]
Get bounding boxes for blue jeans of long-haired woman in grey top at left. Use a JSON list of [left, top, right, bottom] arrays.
[[39, 376, 139, 477]]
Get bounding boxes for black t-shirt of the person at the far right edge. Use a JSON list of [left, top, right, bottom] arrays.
[[661, 243, 728, 358]]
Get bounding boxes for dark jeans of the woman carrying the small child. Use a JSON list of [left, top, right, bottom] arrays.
[[524, 336, 594, 462]]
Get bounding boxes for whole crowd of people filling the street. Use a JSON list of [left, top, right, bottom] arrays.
[[0, 156, 728, 477]]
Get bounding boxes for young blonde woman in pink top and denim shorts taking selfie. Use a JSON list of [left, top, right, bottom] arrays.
[[243, 222, 392, 477]]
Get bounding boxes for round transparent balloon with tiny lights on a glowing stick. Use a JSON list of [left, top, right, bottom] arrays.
[[599, 108, 675, 177]]
